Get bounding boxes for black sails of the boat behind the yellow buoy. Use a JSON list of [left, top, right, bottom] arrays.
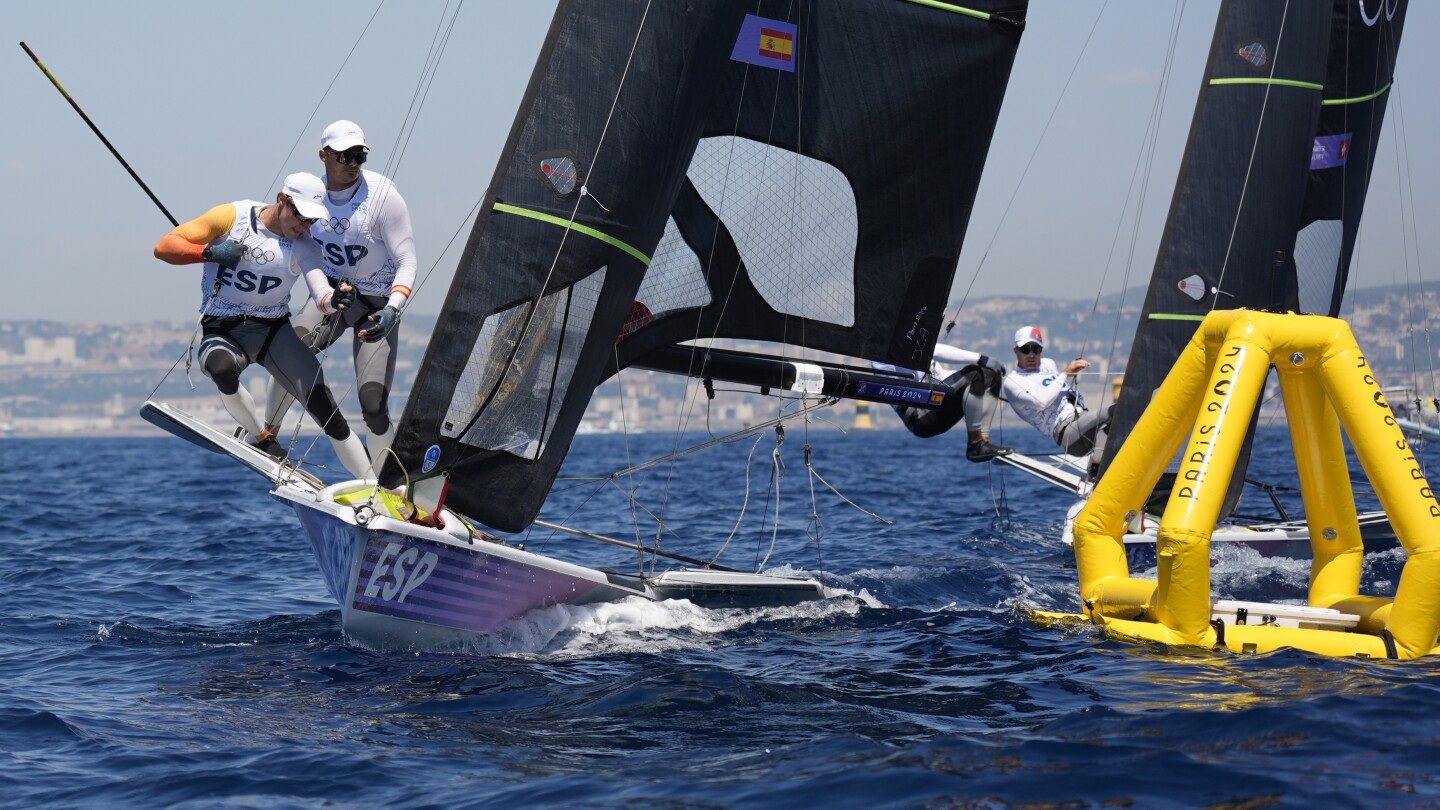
[[1102, 0, 1405, 484]]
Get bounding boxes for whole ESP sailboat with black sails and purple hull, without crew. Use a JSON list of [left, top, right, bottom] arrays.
[[145, 0, 1025, 647]]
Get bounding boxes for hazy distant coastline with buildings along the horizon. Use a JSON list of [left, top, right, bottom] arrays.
[[0, 285, 1440, 440]]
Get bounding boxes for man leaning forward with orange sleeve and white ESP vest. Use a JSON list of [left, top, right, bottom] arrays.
[[156, 172, 370, 479]]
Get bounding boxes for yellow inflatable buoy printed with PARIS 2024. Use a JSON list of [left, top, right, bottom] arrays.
[[1041, 310, 1440, 659]]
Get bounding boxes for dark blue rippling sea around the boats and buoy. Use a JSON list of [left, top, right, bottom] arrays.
[[0, 422, 1440, 809]]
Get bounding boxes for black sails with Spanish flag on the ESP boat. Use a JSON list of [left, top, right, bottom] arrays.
[[384, 0, 1025, 530]]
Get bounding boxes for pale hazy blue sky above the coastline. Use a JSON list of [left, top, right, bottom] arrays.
[[0, 0, 1440, 321]]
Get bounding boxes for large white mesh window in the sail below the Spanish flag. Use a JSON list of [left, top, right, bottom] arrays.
[[688, 135, 860, 326]]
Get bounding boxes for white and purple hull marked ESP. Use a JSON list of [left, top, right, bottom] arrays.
[[272, 481, 837, 649]]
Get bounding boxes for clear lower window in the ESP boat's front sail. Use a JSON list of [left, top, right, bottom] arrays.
[[441, 267, 606, 460]]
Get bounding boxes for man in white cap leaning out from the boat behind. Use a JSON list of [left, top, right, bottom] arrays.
[[1004, 326, 1110, 455]]
